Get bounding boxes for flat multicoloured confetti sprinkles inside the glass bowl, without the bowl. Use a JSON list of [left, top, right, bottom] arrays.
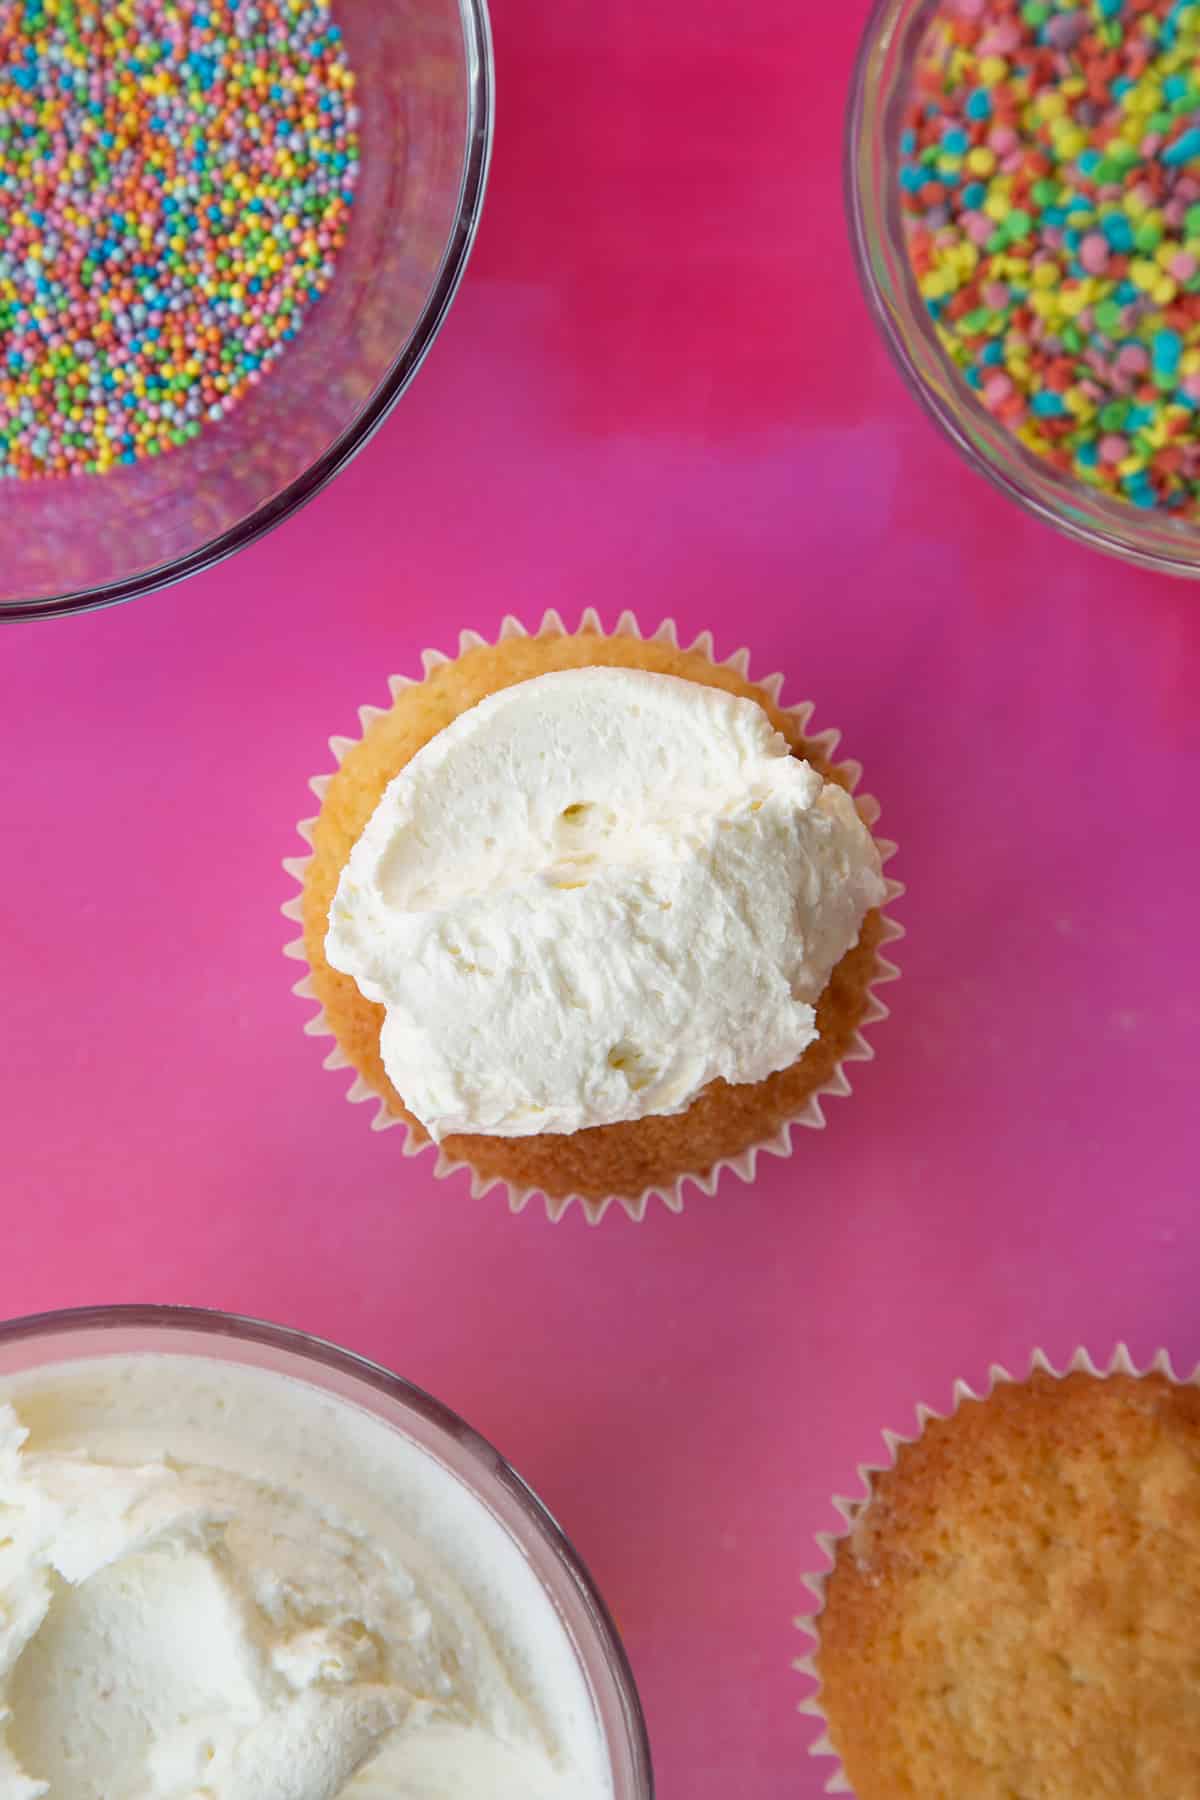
[[900, 0, 1200, 517]]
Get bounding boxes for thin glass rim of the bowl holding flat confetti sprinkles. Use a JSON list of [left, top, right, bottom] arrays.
[[842, 0, 1200, 580]]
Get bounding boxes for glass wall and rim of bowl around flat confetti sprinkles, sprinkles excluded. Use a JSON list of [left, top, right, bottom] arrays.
[[846, 0, 1200, 576]]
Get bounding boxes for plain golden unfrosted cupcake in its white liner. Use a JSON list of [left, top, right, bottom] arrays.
[[801, 1352, 1200, 1800]]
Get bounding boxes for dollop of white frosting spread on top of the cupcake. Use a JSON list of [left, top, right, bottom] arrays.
[[326, 668, 885, 1139]]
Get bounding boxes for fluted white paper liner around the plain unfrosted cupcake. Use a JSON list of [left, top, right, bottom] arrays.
[[792, 1343, 1200, 1795]]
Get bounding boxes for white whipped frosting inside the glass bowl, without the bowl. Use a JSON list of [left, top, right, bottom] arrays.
[[0, 1359, 610, 1800]]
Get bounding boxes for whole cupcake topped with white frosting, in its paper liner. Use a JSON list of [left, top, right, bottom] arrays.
[[284, 614, 898, 1219]]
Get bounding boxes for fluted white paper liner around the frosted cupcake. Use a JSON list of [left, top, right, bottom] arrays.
[[282, 607, 905, 1224]]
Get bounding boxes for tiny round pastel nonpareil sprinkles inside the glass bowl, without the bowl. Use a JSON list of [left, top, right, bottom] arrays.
[[0, 0, 358, 477]]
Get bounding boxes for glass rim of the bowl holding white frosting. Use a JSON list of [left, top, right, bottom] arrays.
[[0, 1301, 655, 1800]]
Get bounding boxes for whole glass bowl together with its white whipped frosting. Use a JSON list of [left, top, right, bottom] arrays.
[[0, 1307, 653, 1800]]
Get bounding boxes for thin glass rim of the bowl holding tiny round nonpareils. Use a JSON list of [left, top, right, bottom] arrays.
[[8, 0, 497, 623]]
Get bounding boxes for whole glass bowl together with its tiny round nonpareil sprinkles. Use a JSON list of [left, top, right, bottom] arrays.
[[0, 0, 493, 619]]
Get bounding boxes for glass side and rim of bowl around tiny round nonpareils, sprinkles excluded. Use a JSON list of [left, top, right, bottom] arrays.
[[0, 0, 493, 617]]
